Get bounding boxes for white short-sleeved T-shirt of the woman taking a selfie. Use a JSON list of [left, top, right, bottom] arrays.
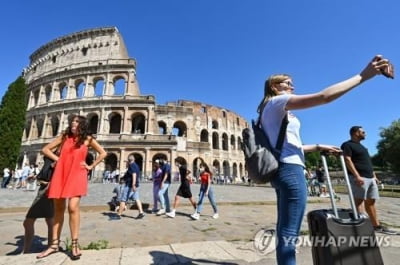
[[261, 94, 304, 166]]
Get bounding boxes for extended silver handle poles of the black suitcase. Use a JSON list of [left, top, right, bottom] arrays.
[[321, 152, 360, 220]]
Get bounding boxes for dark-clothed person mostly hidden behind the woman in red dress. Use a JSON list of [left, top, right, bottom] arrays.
[[23, 182, 54, 253]]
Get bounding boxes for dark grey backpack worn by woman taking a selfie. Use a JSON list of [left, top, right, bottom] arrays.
[[242, 103, 289, 184]]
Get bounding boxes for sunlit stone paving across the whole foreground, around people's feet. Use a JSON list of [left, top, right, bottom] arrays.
[[0, 184, 400, 265]]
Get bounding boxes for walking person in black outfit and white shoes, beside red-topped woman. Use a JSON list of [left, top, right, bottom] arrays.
[[166, 158, 196, 218]]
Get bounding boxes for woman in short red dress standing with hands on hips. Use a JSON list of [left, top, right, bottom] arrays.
[[37, 115, 107, 259]]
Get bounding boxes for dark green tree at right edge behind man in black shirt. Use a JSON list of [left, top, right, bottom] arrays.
[[377, 119, 400, 173]]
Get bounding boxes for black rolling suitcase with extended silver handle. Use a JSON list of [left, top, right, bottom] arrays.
[[307, 153, 384, 265]]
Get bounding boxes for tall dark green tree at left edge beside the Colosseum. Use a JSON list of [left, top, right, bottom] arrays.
[[0, 76, 26, 169]]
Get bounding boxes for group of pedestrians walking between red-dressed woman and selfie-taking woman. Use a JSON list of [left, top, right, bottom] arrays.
[[110, 155, 219, 220]]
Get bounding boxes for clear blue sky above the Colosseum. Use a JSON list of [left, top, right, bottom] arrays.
[[0, 0, 400, 154]]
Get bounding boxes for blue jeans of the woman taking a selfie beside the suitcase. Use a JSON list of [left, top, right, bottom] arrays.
[[271, 163, 307, 265]]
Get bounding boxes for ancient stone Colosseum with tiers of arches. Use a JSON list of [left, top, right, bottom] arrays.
[[20, 27, 248, 181]]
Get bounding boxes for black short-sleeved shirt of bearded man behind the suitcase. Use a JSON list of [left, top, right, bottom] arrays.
[[341, 140, 374, 178]]
